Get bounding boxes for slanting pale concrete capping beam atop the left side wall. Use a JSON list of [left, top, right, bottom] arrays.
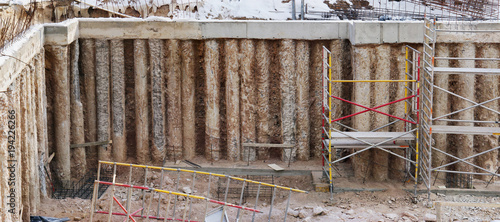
[[0, 25, 44, 92]]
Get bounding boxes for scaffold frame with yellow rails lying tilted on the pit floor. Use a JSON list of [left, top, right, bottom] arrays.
[[90, 161, 307, 222]]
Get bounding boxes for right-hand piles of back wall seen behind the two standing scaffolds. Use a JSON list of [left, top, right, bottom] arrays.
[[333, 43, 500, 181]]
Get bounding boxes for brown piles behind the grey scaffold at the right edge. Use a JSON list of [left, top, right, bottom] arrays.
[[433, 43, 500, 180]]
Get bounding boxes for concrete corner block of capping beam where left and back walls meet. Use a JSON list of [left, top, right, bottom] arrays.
[[44, 19, 79, 45]]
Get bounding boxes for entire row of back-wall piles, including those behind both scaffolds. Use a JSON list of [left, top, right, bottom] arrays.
[[48, 39, 498, 184]]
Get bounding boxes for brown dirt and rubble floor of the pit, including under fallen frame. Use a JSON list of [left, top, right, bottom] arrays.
[[38, 159, 500, 221]]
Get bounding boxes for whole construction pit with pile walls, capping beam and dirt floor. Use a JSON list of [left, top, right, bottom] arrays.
[[0, 2, 500, 221]]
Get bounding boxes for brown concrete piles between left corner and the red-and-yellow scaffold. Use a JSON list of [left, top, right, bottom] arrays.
[[46, 39, 344, 180]]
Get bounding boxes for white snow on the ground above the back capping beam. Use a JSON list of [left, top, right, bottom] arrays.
[[0, 0, 480, 20]]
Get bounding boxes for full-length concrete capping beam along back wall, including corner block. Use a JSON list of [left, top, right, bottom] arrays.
[[45, 18, 500, 45]]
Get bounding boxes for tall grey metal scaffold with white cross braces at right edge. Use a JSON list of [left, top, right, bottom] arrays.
[[419, 17, 500, 200]]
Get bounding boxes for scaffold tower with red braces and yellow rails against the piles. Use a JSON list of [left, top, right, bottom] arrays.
[[322, 46, 421, 199]]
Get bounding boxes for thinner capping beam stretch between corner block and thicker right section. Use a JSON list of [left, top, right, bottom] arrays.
[[77, 19, 349, 40]]
